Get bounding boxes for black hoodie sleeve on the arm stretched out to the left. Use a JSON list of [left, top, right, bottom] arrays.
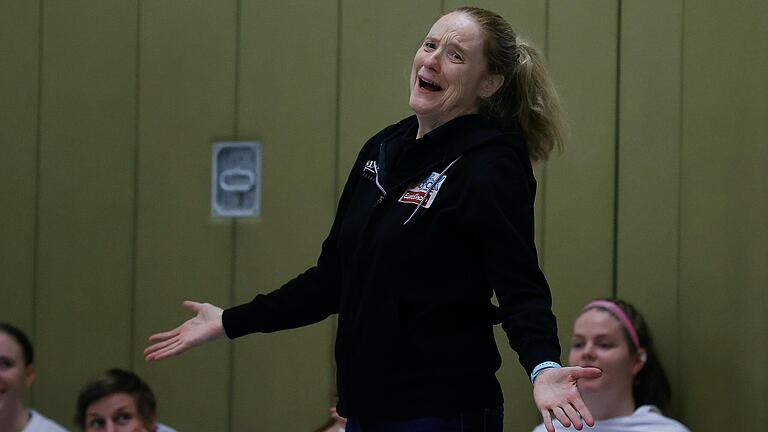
[[222, 145, 369, 339]]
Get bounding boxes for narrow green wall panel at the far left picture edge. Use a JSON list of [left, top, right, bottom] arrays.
[[0, 0, 40, 341]]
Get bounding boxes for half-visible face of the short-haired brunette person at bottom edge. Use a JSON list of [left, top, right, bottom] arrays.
[[85, 393, 153, 432]]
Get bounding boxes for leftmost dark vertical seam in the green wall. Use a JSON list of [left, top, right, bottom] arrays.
[[29, 0, 44, 406]]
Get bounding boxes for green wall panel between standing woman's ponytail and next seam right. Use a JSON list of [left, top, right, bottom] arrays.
[[544, 0, 618, 346]]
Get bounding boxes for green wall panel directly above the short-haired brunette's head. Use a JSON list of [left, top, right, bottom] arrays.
[[35, 1, 136, 424]]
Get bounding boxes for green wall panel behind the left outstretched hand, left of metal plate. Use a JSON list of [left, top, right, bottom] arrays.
[[133, 0, 237, 431]]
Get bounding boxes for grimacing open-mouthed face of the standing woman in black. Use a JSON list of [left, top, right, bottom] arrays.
[[410, 12, 503, 126]]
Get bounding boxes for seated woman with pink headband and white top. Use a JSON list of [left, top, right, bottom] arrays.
[[534, 299, 690, 432]]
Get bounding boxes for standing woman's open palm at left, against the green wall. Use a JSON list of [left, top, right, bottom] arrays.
[[144, 300, 224, 361]]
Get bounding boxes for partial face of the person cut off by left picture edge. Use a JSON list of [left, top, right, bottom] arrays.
[[0, 332, 35, 411]]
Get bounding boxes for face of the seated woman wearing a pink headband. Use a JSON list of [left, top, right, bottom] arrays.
[[568, 309, 644, 393]]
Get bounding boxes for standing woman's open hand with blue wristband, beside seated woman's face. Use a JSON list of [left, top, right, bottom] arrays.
[[533, 366, 602, 432]]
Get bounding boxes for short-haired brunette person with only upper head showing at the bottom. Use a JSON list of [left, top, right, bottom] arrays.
[[75, 369, 175, 432]]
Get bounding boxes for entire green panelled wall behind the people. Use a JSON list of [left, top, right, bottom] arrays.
[[0, 0, 768, 431]]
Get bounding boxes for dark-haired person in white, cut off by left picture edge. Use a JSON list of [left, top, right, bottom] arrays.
[[0, 322, 67, 432]]
